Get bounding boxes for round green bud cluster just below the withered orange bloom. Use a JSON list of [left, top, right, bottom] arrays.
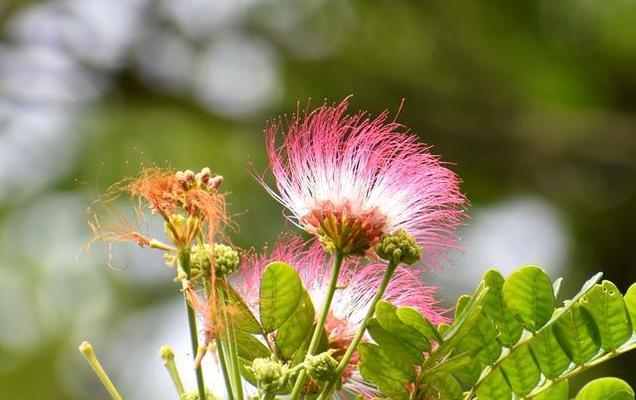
[[191, 243, 240, 277]]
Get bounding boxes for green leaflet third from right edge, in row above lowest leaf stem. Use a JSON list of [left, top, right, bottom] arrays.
[[554, 303, 600, 365]]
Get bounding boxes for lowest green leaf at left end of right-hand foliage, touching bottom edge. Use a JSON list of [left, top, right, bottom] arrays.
[[358, 343, 415, 400]]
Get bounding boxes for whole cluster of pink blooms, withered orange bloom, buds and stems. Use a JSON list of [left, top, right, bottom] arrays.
[[82, 99, 466, 400]]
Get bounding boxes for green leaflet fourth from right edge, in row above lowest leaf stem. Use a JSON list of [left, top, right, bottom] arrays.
[[530, 326, 570, 379]]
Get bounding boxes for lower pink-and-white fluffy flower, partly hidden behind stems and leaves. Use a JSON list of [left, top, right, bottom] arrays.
[[234, 236, 449, 398]]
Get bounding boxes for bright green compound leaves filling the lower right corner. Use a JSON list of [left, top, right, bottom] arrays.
[[359, 265, 636, 400]]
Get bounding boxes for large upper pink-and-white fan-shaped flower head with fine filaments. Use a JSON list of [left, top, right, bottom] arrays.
[[265, 98, 466, 262]]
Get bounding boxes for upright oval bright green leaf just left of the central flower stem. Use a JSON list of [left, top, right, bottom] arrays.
[[259, 262, 304, 332]]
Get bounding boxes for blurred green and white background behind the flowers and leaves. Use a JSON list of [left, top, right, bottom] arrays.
[[0, 0, 636, 400]]
